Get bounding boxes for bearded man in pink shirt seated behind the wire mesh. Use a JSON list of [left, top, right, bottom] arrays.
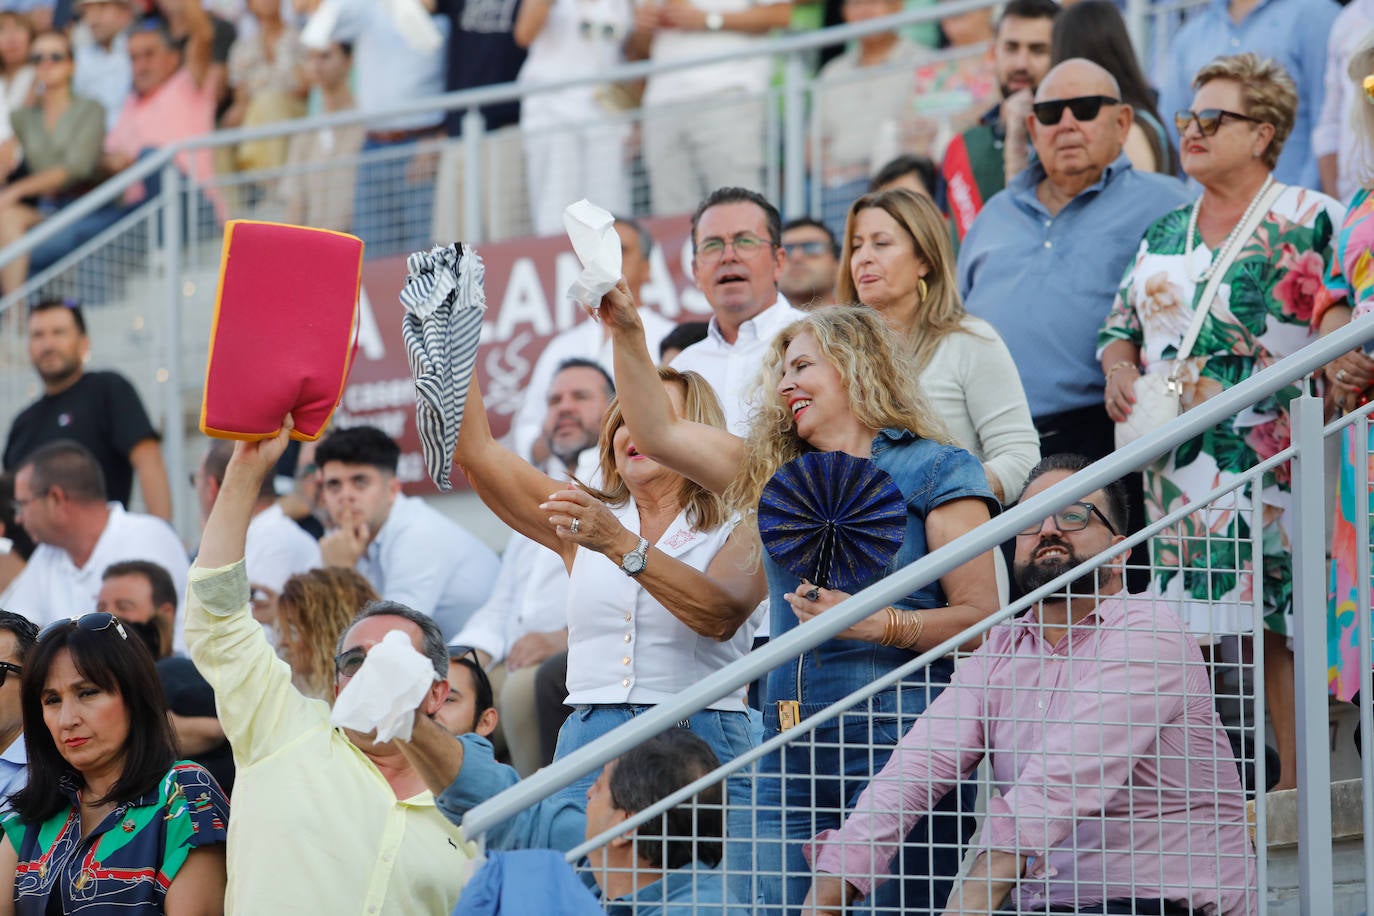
[[807, 455, 1257, 915]]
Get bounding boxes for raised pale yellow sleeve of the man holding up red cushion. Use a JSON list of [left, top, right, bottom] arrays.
[[185, 560, 330, 766]]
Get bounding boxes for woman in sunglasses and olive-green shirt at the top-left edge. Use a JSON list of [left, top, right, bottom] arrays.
[[0, 32, 104, 293]]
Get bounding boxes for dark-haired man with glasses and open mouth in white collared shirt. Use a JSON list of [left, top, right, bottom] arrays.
[[673, 188, 805, 435]]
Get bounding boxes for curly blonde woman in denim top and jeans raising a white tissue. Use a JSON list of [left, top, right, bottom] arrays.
[[600, 284, 998, 912]]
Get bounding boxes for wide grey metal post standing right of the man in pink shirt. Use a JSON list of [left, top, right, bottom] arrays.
[[1291, 382, 1336, 913]]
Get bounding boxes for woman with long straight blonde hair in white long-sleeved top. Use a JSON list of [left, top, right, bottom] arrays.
[[837, 190, 1040, 501]]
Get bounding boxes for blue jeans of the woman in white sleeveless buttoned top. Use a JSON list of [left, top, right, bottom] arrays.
[[554, 706, 758, 902]]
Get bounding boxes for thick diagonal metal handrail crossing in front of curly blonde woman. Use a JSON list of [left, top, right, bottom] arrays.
[[463, 315, 1374, 836]]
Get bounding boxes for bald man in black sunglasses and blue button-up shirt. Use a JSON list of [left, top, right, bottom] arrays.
[[959, 59, 1189, 585]]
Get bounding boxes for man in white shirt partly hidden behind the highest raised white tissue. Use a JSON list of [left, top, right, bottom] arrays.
[[511, 217, 677, 464]]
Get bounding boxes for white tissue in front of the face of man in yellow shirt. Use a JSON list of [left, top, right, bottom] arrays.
[[330, 630, 437, 742]]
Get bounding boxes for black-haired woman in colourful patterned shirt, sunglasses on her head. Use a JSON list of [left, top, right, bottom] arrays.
[[0, 614, 229, 916]]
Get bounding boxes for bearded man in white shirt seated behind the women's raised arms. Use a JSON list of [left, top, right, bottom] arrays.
[[452, 360, 616, 777]]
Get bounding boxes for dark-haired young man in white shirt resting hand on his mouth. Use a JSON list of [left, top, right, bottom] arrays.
[[315, 426, 500, 639]]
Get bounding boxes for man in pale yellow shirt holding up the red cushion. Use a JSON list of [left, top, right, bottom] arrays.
[[185, 426, 475, 916]]
